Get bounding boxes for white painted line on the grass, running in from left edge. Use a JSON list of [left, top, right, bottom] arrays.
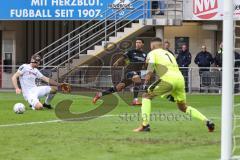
[[0, 115, 119, 128]]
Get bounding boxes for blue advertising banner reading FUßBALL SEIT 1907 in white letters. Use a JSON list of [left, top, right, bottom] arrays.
[[0, 0, 147, 20]]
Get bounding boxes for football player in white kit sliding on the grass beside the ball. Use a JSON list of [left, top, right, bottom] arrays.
[[12, 55, 59, 110]]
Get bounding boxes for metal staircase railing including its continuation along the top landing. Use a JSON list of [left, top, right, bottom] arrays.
[[32, 0, 183, 71]]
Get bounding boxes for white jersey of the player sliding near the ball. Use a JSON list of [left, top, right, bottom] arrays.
[[18, 64, 43, 96]]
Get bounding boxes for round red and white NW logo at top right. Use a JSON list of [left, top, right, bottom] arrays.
[[193, 0, 218, 19]]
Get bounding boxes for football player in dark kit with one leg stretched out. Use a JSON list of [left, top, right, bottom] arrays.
[[93, 39, 147, 105]]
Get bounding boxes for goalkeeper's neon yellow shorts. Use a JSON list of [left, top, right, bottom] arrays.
[[148, 76, 186, 102]]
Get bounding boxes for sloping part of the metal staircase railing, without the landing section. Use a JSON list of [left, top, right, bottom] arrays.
[[36, 0, 147, 69]]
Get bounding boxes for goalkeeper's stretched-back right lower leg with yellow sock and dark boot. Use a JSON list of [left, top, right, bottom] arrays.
[[177, 102, 215, 132]]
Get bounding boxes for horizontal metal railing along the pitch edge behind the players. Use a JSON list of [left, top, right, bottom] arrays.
[[0, 66, 240, 94]]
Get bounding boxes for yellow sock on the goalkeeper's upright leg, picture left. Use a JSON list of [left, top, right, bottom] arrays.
[[141, 98, 151, 126]]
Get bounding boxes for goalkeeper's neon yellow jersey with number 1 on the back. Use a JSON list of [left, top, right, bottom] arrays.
[[147, 49, 182, 80]]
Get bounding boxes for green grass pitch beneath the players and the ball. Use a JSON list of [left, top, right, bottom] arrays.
[[0, 93, 240, 160]]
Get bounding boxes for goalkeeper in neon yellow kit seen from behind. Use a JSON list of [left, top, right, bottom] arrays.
[[134, 38, 214, 132]]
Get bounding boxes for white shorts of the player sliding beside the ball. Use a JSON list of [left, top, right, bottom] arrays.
[[24, 86, 51, 109]]
